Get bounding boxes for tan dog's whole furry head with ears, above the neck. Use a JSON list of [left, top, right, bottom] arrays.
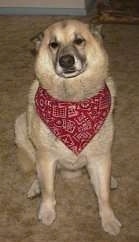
[[32, 20, 107, 98]]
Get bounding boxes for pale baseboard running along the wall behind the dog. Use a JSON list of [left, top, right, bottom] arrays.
[[0, 7, 88, 16]]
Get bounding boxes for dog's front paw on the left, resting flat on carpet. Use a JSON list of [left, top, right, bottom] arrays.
[[38, 203, 56, 225]]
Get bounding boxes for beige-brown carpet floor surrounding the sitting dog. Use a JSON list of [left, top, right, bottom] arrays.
[[0, 16, 139, 242]]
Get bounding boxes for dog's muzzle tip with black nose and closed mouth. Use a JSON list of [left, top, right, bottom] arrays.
[[55, 54, 86, 78]]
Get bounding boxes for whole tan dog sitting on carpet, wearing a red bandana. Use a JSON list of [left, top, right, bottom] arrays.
[[15, 20, 121, 235]]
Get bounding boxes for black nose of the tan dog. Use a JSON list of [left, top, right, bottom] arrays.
[[59, 55, 75, 68]]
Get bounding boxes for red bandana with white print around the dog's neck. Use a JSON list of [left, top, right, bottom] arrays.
[[35, 85, 111, 154]]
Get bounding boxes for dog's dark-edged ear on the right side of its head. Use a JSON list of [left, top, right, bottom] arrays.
[[90, 23, 104, 41]]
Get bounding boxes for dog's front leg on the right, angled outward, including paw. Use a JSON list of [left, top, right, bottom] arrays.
[[87, 154, 121, 235]]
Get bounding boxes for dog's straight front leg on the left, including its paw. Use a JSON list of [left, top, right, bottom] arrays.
[[37, 149, 56, 225]]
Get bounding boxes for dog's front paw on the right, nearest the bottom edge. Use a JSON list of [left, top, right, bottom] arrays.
[[102, 211, 121, 235]]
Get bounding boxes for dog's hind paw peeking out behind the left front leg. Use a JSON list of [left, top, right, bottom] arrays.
[[27, 179, 41, 199]]
